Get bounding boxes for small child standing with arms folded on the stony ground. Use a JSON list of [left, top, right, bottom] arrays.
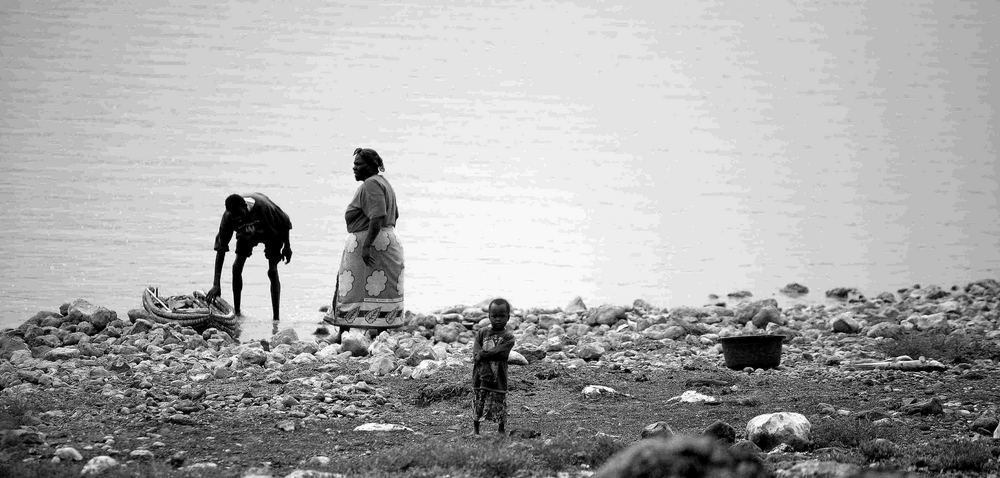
[[472, 299, 514, 435]]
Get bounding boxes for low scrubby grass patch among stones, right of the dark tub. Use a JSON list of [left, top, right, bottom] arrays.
[[878, 332, 1000, 363]]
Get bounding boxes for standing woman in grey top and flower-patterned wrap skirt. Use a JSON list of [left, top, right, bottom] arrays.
[[325, 148, 403, 331]]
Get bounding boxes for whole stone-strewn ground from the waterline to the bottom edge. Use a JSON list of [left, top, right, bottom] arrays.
[[0, 280, 1000, 477]]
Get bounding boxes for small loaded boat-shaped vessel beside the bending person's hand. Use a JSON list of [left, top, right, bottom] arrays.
[[142, 286, 239, 337]]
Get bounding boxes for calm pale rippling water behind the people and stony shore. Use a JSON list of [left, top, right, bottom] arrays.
[[0, 0, 1000, 337]]
